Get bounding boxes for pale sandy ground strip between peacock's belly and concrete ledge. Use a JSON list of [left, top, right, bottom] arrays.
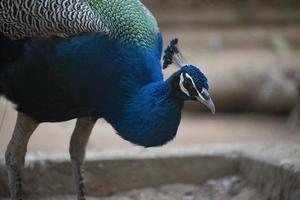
[[0, 101, 300, 156]]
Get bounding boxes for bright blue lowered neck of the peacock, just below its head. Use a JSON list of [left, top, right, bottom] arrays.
[[105, 79, 183, 147]]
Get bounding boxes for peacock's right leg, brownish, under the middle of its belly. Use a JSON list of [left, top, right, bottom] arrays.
[[70, 117, 97, 200]]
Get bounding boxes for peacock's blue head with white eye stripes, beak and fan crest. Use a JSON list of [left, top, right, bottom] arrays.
[[163, 39, 215, 114]]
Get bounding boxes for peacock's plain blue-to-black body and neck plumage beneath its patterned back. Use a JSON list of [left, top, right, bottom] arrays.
[[1, 33, 183, 147]]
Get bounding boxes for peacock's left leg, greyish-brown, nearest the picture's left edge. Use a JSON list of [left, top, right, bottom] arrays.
[[5, 113, 38, 200]]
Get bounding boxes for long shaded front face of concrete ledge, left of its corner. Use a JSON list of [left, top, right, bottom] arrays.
[[0, 156, 239, 198]]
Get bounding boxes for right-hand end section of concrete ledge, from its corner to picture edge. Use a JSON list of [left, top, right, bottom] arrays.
[[240, 142, 300, 200]]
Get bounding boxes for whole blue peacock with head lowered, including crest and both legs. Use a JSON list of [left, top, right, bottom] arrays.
[[0, 0, 215, 200]]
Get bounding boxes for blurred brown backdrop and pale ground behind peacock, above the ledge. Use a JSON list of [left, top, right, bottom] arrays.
[[0, 0, 300, 157]]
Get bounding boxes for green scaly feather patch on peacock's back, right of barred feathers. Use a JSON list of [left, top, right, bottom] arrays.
[[87, 0, 158, 46]]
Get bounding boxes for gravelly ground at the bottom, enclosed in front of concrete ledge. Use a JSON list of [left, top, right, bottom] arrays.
[[2, 176, 266, 200]]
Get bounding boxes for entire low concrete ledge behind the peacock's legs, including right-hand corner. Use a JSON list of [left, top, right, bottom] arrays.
[[0, 144, 300, 200]]
